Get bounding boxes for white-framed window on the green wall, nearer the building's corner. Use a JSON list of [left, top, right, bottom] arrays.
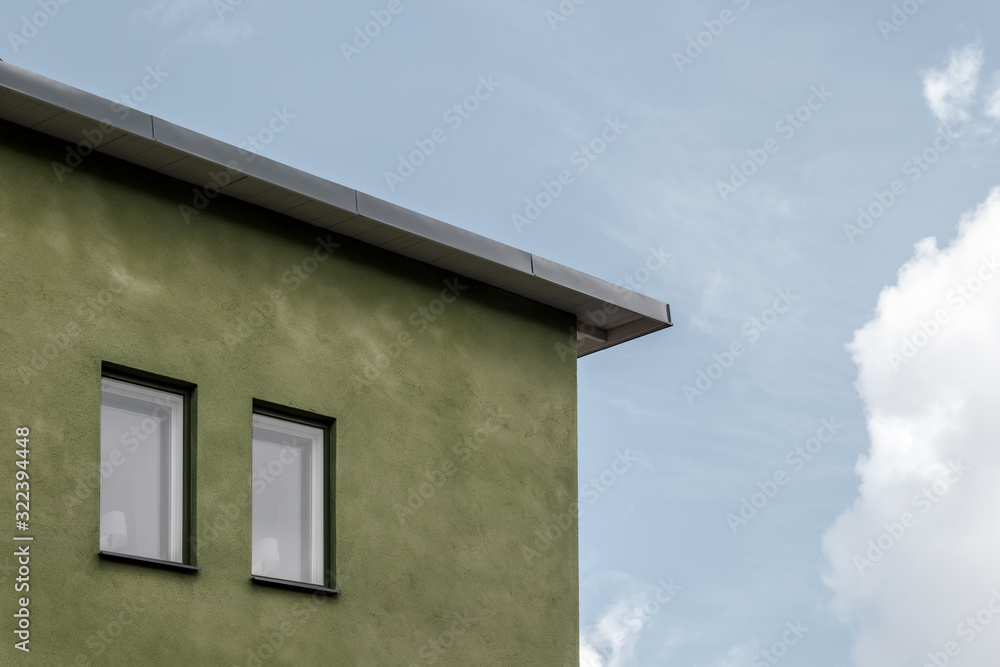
[[251, 412, 328, 586]]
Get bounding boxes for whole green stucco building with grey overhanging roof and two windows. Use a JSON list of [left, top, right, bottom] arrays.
[[0, 63, 670, 667]]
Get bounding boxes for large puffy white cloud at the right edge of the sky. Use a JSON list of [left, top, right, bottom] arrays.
[[824, 188, 1000, 667]]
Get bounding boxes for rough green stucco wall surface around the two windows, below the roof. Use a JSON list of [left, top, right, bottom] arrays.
[[0, 123, 578, 667]]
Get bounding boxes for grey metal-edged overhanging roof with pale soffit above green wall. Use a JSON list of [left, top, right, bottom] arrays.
[[0, 61, 672, 357]]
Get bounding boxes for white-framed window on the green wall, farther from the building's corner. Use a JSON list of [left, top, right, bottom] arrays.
[[100, 376, 189, 563]]
